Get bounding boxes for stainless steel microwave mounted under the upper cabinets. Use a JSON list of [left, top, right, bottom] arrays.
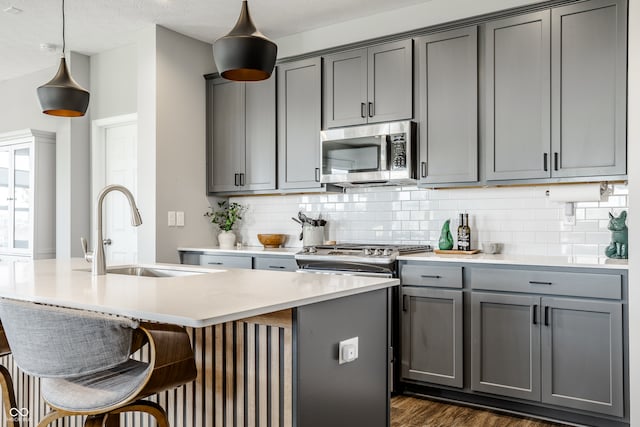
[[320, 121, 417, 187]]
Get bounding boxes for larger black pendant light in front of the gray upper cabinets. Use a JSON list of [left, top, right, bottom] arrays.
[[213, 0, 278, 82]]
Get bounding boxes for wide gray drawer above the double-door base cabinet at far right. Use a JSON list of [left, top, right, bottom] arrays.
[[471, 268, 622, 299]]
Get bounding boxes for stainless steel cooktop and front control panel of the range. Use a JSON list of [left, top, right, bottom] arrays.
[[295, 243, 431, 277]]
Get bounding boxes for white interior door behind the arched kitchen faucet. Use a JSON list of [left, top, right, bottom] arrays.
[[93, 117, 138, 265]]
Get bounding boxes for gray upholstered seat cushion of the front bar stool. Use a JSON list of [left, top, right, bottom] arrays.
[[40, 359, 150, 412]]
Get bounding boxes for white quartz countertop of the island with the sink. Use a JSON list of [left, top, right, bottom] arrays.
[[0, 259, 399, 328]]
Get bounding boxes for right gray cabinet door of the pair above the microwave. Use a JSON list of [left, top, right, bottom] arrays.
[[366, 39, 413, 123]]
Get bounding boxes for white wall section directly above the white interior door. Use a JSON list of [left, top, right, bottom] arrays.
[[91, 44, 138, 120]]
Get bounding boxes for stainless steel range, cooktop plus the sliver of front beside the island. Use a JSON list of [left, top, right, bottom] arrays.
[[295, 243, 432, 392]]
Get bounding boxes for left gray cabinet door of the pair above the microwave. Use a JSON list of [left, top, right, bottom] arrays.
[[324, 49, 368, 128]]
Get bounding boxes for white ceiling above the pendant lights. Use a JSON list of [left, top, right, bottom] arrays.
[[0, 0, 436, 81]]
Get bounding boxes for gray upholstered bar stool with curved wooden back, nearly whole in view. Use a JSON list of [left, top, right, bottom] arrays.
[[0, 299, 197, 427]]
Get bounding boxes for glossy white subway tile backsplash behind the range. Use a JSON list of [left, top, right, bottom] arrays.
[[228, 185, 628, 256]]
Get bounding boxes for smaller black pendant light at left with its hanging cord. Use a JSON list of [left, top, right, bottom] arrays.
[[38, 0, 89, 117]]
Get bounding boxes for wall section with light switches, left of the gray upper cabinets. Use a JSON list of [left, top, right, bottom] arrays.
[[156, 27, 214, 262]]
